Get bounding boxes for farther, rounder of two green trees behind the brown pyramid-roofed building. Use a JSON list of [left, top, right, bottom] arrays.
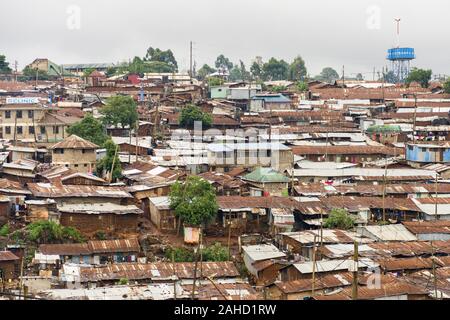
[[100, 96, 139, 130]]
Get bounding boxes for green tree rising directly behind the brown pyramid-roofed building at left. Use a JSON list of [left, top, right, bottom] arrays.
[[67, 114, 108, 146]]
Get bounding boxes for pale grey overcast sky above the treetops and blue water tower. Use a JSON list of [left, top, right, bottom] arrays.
[[0, 0, 450, 79]]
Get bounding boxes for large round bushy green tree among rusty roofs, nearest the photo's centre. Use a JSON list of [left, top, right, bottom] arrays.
[[169, 176, 219, 227]]
